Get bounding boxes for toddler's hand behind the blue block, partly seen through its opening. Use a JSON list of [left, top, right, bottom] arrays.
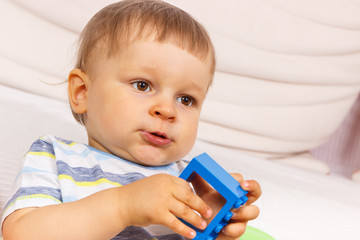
[[192, 173, 261, 240]]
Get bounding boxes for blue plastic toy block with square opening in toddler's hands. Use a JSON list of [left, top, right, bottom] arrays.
[[180, 153, 248, 240]]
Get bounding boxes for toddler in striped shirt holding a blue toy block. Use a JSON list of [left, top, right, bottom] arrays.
[[2, 0, 261, 240]]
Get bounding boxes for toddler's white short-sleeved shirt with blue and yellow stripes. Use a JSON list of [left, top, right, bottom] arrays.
[[2, 136, 186, 239]]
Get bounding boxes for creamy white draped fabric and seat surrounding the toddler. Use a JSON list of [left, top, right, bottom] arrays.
[[0, 0, 360, 240]]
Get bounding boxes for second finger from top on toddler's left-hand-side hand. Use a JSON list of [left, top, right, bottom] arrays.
[[170, 201, 207, 230]]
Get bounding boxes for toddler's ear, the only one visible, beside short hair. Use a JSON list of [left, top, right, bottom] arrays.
[[68, 68, 89, 114]]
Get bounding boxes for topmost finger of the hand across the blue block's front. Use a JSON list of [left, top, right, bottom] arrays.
[[173, 182, 212, 218]]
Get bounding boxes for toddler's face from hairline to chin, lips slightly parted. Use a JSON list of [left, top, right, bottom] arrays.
[[85, 41, 211, 166]]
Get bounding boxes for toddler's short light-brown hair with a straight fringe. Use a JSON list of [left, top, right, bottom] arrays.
[[73, 0, 215, 123]]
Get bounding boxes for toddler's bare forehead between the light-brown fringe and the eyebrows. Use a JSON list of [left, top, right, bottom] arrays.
[[94, 40, 212, 94]]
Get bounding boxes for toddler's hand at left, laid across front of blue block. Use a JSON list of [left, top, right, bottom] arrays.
[[121, 174, 212, 238]]
